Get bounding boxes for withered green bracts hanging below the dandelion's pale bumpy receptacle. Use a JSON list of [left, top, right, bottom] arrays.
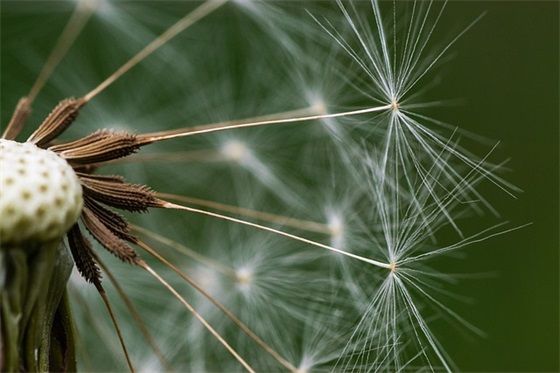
[[0, 241, 76, 372]]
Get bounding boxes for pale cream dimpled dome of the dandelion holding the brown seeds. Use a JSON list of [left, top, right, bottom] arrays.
[[0, 139, 83, 244]]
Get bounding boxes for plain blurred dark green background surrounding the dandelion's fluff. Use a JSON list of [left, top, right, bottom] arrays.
[[1, 1, 560, 372]]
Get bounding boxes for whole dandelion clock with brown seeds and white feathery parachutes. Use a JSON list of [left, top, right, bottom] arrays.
[[0, 0, 515, 372]]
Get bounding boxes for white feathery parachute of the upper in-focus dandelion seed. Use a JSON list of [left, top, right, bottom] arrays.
[[310, 1, 518, 215]]
